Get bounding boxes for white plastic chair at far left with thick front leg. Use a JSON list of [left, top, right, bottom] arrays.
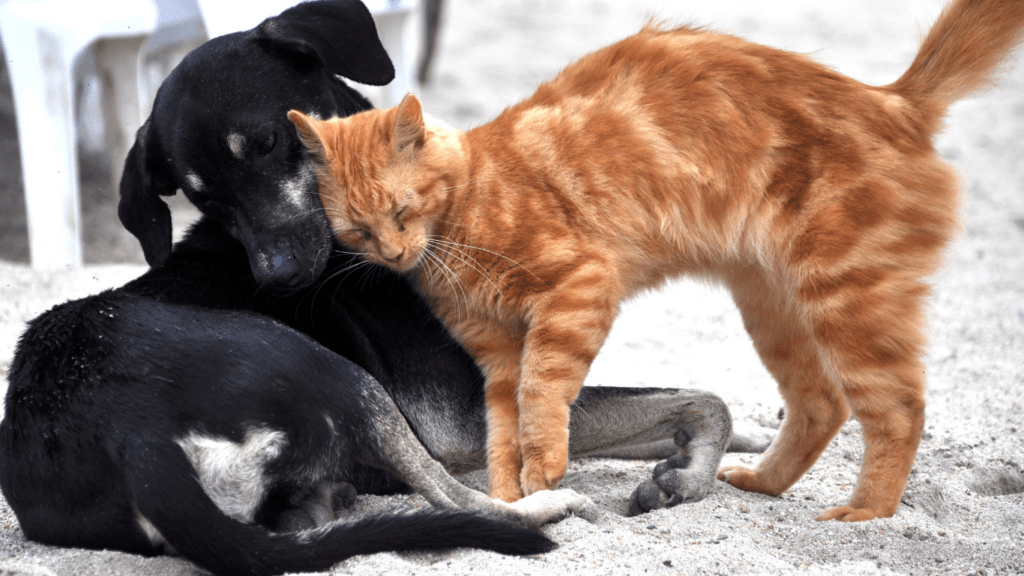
[[0, 0, 157, 270]]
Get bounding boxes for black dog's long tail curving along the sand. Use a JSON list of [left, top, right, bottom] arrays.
[[127, 445, 555, 575]]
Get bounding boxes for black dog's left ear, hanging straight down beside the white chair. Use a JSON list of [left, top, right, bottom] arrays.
[[118, 121, 177, 268]]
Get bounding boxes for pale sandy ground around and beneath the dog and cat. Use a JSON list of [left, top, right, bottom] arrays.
[[0, 0, 1024, 576]]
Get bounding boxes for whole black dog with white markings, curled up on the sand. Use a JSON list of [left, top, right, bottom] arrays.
[[0, 1, 760, 574]]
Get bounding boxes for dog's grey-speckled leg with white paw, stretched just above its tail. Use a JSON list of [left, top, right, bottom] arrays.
[[362, 380, 594, 527]]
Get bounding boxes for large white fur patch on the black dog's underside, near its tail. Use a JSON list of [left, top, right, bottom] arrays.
[[176, 428, 288, 523]]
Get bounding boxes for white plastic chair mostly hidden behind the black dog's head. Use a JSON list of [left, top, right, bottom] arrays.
[[199, 0, 418, 106]]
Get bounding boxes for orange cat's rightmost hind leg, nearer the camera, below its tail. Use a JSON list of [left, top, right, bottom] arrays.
[[798, 274, 928, 522]]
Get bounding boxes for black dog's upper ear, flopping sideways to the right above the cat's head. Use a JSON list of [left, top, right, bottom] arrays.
[[255, 0, 394, 86]]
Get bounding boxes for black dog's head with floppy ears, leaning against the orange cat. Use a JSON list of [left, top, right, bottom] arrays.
[[118, 0, 394, 289]]
